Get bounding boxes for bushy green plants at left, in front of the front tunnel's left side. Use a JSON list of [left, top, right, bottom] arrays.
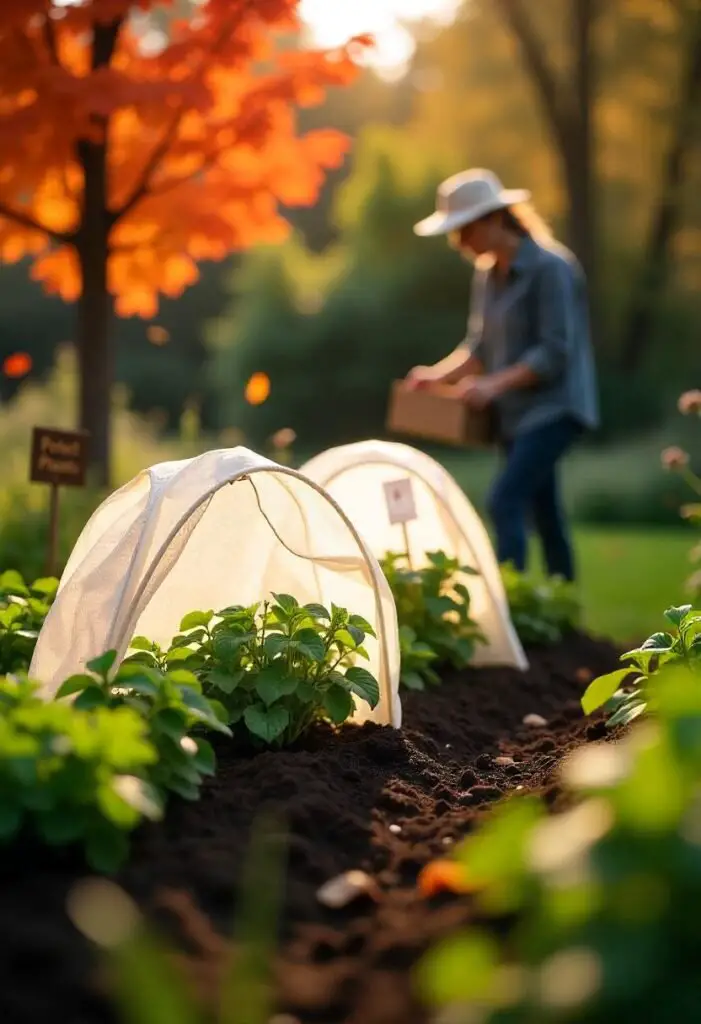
[[0, 638, 231, 870]]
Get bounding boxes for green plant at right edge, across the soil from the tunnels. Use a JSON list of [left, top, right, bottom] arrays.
[[581, 604, 701, 728]]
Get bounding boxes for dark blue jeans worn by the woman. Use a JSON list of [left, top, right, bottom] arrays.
[[488, 418, 582, 581]]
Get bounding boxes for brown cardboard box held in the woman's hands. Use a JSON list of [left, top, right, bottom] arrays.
[[387, 381, 494, 447]]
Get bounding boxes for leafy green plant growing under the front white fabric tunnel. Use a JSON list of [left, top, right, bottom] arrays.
[[123, 594, 380, 746]]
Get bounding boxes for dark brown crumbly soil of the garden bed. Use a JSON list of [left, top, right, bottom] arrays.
[[0, 635, 617, 1024]]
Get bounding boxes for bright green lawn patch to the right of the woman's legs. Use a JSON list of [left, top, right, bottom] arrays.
[[575, 527, 695, 643]]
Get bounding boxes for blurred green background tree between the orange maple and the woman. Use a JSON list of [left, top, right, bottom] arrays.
[[206, 127, 470, 446]]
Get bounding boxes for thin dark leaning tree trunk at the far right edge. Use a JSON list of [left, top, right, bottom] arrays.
[[620, 8, 701, 373]]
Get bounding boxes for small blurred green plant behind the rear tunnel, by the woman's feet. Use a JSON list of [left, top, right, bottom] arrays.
[[501, 564, 581, 646]]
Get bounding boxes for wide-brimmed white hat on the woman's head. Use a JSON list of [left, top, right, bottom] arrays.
[[413, 170, 531, 237]]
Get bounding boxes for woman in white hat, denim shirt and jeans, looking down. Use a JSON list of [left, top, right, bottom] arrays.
[[406, 170, 599, 581]]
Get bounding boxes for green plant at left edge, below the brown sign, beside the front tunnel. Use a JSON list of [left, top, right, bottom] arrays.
[[0, 569, 58, 675]]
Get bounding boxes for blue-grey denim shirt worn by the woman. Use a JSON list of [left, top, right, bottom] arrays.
[[463, 237, 599, 438]]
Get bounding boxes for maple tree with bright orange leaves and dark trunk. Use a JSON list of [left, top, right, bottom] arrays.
[[0, 0, 366, 483]]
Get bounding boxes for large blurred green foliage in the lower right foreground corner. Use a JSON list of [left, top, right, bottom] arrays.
[[421, 665, 701, 1024]]
